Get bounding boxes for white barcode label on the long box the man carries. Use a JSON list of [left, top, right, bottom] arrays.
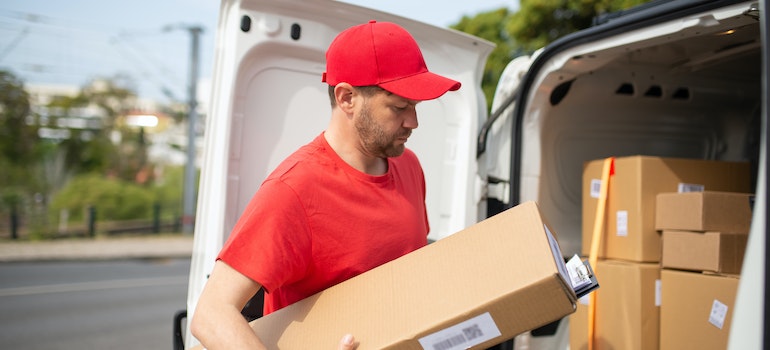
[[419, 312, 501, 350]]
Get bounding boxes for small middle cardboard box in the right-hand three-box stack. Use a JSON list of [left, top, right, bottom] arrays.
[[661, 230, 749, 274]]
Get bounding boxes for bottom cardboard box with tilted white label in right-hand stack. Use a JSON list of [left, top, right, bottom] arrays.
[[660, 269, 739, 350]]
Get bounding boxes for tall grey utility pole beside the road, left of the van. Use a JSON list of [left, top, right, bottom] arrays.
[[166, 25, 203, 234]]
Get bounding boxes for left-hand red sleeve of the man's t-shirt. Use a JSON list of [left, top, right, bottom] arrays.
[[217, 179, 311, 292]]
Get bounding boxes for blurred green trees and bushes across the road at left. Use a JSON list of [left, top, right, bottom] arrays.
[[0, 71, 170, 237]]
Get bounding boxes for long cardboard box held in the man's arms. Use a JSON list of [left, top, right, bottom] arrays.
[[246, 202, 576, 350]]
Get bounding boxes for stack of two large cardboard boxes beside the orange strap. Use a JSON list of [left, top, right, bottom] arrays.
[[570, 156, 750, 349]]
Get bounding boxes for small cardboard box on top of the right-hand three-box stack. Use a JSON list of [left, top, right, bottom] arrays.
[[655, 191, 753, 233]]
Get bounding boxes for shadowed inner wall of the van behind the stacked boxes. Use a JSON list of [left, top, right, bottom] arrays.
[[525, 56, 761, 255]]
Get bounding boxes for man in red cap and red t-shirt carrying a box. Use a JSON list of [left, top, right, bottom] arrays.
[[191, 21, 460, 350]]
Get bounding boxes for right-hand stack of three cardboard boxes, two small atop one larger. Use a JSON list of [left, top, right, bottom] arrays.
[[655, 192, 752, 350]]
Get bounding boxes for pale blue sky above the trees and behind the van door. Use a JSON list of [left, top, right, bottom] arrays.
[[0, 0, 518, 103]]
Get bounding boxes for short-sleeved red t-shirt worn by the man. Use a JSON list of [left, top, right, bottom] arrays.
[[218, 134, 429, 314]]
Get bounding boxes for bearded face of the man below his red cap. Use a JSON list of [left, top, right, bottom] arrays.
[[355, 91, 418, 158]]
